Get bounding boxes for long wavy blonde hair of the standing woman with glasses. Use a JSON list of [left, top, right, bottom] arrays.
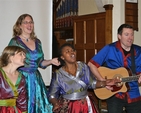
[[13, 14, 37, 39]]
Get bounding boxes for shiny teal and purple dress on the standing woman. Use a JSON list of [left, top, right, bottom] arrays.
[[9, 37, 52, 113]]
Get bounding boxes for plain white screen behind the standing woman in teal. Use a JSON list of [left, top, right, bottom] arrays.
[[0, 0, 52, 86]]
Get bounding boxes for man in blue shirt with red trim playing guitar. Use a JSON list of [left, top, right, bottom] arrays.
[[88, 24, 141, 113]]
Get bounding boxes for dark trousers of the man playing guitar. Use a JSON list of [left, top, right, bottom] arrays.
[[106, 96, 141, 113]]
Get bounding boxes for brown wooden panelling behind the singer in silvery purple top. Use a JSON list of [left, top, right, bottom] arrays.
[[73, 13, 105, 63]]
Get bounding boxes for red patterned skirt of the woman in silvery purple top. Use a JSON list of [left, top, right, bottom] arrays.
[[54, 97, 99, 113]]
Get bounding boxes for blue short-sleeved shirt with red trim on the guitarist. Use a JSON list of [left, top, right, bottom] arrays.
[[90, 41, 141, 103]]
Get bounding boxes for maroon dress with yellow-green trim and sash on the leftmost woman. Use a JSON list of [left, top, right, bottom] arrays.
[[0, 68, 27, 113]]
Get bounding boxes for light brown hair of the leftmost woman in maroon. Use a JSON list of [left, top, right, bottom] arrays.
[[0, 46, 26, 67]]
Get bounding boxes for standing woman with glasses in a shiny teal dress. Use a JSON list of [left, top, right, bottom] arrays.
[[9, 14, 60, 113]]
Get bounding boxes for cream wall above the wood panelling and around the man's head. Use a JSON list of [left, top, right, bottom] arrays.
[[78, 0, 141, 45]]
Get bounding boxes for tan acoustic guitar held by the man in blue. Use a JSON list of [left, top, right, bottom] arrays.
[[94, 67, 140, 100]]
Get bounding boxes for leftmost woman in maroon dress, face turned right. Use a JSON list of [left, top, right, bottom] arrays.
[[0, 46, 27, 113]]
